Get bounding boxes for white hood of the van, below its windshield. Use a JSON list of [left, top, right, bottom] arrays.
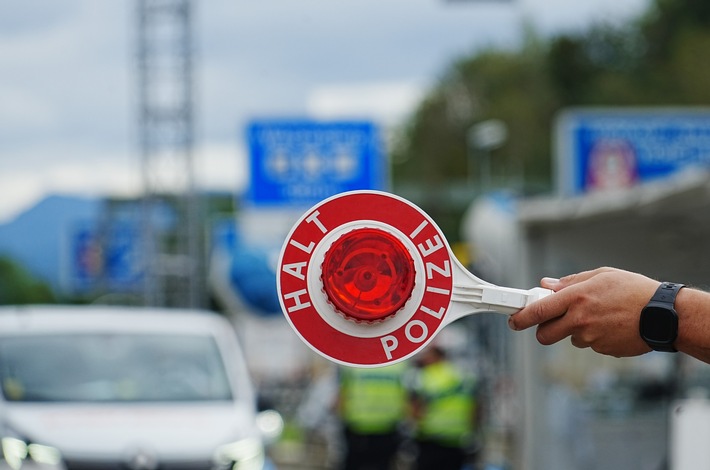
[[5, 403, 258, 459]]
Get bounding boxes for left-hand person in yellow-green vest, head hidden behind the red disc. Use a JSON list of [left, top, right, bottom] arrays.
[[337, 363, 408, 470]]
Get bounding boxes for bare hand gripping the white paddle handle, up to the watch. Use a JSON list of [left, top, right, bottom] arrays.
[[508, 268, 660, 357]]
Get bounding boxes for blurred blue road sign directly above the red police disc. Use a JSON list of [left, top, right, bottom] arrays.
[[246, 120, 387, 206]]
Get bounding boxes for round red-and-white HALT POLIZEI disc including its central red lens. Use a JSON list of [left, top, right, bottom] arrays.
[[277, 191, 454, 366]]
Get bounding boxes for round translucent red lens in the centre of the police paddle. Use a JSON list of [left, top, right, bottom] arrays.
[[323, 228, 415, 321]]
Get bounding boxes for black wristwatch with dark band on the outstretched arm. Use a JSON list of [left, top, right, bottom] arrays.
[[639, 282, 685, 352]]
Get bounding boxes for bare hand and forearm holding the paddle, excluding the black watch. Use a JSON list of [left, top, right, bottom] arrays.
[[508, 267, 710, 364]]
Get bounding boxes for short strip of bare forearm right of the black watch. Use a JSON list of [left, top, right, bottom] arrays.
[[675, 287, 710, 363]]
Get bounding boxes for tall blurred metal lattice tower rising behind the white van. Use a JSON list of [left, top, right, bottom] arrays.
[[137, 0, 204, 307]]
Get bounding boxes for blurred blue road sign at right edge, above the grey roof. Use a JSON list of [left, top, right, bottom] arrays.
[[556, 108, 710, 194]]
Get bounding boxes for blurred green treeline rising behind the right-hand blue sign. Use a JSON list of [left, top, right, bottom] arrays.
[[391, 0, 710, 240]]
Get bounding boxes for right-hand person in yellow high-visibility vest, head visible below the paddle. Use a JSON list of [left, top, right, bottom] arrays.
[[410, 345, 477, 470]]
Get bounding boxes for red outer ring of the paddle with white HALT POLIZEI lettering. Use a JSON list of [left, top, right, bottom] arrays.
[[278, 191, 453, 366]]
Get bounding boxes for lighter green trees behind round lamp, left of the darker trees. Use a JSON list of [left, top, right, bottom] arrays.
[[392, 35, 557, 241]]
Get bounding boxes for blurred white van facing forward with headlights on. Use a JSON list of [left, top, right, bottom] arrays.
[[0, 306, 278, 470]]
